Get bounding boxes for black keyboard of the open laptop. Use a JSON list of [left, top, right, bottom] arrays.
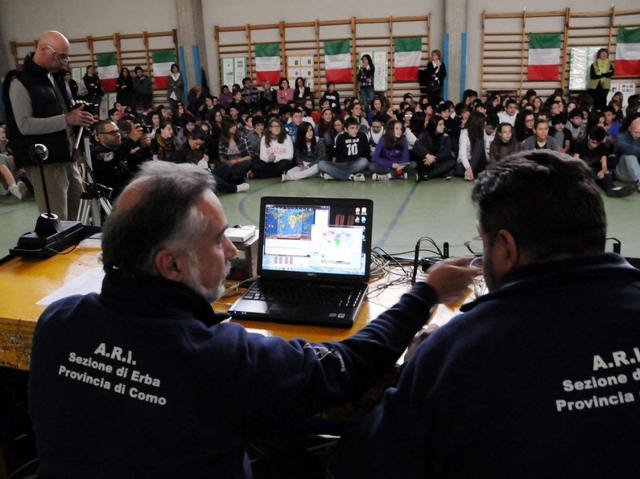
[[244, 280, 362, 307]]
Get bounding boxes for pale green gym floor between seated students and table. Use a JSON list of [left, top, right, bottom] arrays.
[[0, 177, 640, 258]]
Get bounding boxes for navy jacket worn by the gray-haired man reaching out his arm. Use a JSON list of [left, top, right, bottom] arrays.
[[29, 272, 436, 479]]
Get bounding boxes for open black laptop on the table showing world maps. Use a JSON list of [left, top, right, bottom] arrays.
[[229, 197, 373, 328]]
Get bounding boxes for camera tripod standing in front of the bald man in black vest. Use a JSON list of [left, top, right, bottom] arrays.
[[75, 127, 112, 226]]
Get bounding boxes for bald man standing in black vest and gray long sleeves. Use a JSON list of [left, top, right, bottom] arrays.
[[2, 31, 93, 220]]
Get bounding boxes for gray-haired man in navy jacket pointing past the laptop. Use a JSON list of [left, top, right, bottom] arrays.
[[29, 162, 477, 479]]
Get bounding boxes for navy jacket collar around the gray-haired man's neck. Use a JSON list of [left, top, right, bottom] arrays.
[[100, 269, 229, 326]]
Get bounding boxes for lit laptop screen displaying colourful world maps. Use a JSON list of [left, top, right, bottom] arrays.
[[259, 197, 373, 281]]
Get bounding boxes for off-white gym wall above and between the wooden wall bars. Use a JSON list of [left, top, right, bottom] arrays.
[[0, 0, 639, 99]]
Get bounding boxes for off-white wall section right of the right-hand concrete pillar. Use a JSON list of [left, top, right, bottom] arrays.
[[466, 0, 640, 90]]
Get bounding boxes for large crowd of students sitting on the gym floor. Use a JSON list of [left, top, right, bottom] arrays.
[[5, 71, 640, 201]]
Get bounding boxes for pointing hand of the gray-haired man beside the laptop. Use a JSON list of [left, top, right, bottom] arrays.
[[421, 256, 480, 304]]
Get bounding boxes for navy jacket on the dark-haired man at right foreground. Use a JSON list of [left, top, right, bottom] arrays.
[[332, 254, 640, 479]]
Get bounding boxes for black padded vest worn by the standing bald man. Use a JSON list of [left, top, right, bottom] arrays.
[[2, 53, 72, 168]]
